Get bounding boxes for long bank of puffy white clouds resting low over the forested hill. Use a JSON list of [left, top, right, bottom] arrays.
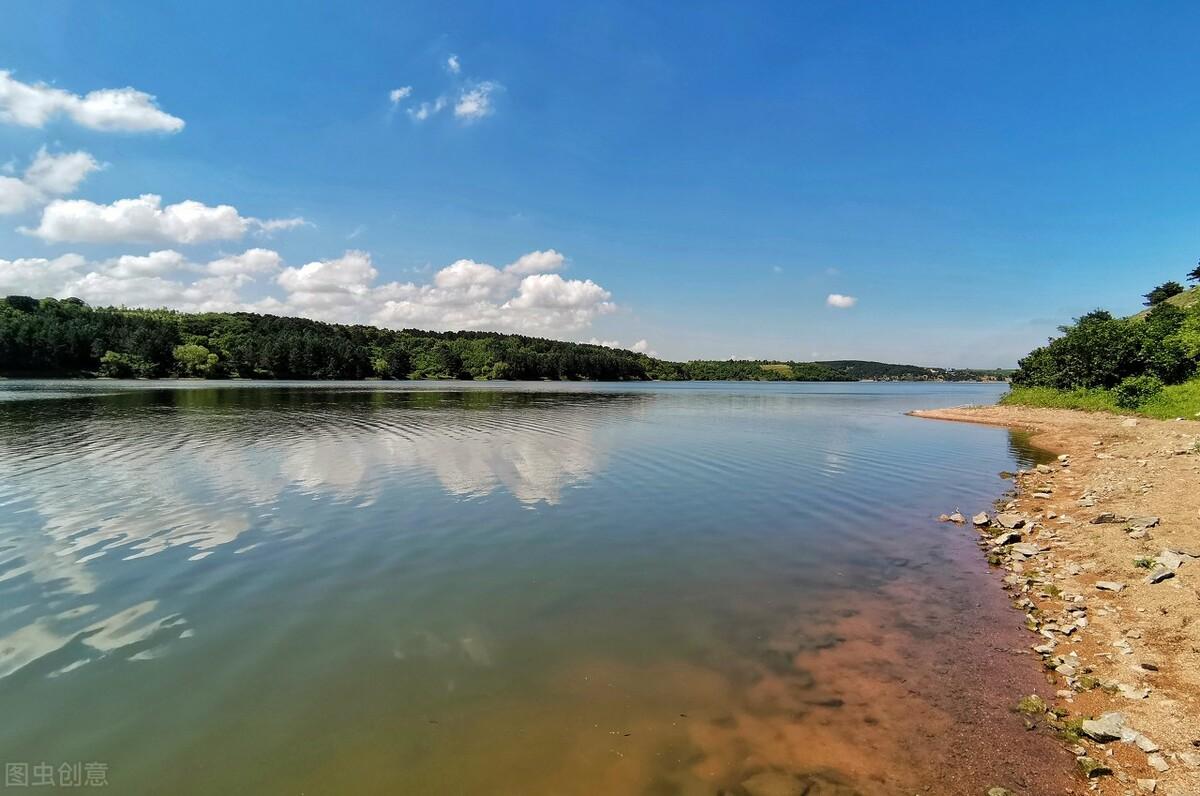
[[0, 249, 619, 336]]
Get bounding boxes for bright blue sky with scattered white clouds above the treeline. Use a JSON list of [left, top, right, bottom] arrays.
[[0, 1, 1200, 366]]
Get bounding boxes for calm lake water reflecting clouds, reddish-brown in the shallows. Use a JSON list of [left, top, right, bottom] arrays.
[[0, 382, 1065, 794]]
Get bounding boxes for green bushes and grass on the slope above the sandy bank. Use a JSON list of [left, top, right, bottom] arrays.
[[1007, 267, 1200, 417]]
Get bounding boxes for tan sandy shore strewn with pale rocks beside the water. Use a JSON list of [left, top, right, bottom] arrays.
[[913, 406, 1200, 796]]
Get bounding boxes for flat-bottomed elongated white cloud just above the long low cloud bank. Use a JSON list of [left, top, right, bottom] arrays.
[[22, 193, 305, 244]]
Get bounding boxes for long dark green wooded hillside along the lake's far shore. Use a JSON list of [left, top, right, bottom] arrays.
[[0, 295, 1000, 382]]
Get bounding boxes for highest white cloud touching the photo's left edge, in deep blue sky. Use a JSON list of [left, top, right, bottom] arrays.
[[0, 70, 184, 132]]
